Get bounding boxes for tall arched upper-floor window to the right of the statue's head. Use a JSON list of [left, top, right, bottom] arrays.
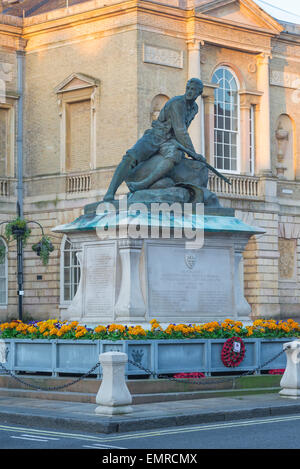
[[212, 67, 240, 172]]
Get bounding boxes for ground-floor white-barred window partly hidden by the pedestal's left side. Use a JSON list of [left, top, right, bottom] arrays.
[[61, 237, 80, 303]]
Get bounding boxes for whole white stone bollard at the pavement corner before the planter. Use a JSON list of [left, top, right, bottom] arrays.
[[95, 352, 132, 415]]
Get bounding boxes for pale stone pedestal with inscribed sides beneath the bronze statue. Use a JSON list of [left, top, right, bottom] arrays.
[[55, 207, 263, 326]]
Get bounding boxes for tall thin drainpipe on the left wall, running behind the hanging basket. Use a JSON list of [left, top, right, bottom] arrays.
[[17, 51, 25, 321]]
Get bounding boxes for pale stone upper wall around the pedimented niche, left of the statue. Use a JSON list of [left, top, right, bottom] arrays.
[[24, 31, 137, 177]]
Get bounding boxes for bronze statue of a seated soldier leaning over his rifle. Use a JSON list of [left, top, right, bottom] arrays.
[[103, 78, 229, 207]]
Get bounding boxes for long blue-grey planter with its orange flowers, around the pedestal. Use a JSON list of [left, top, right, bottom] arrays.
[[0, 319, 300, 377]]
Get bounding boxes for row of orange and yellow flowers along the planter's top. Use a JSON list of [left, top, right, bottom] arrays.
[[0, 319, 300, 340]]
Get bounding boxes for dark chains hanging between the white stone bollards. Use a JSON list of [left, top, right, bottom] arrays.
[[0, 346, 290, 391]]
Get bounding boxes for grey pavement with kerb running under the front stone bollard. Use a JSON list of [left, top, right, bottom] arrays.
[[0, 393, 300, 433]]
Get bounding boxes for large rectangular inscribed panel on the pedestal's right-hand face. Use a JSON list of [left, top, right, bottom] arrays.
[[148, 245, 233, 320]]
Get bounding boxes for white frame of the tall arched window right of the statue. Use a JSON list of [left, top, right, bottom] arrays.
[[213, 65, 241, 174]]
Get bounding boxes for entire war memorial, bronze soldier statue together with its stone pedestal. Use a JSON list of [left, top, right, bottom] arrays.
[[54, 78, 264, 325]]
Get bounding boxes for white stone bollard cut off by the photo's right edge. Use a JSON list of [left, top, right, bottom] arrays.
[[279, 340, 300, 399]]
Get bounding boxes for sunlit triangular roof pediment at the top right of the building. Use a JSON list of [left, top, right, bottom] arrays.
[[195, 0, 284, 34]]
